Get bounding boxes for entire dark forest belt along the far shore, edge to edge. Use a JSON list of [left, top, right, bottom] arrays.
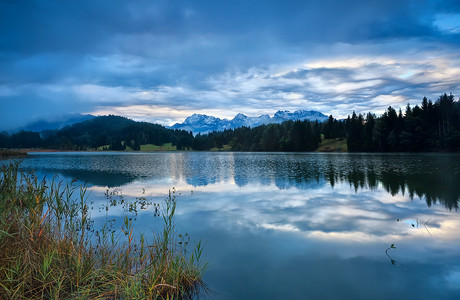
[[0, 94, 460, 152]]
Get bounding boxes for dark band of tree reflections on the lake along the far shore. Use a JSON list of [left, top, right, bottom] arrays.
[[23, 152, 460, 210]]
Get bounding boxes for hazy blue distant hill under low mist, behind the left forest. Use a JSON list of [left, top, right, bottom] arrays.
[[15, 114, 95, 132]]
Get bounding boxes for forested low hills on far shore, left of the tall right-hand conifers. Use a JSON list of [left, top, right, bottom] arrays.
[[0, 115, 321, 151]]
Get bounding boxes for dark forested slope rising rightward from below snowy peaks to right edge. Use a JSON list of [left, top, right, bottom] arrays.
[[197, 94, 460, 152]]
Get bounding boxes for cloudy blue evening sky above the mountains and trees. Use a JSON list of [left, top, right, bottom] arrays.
[[0, 0, 460, 130]]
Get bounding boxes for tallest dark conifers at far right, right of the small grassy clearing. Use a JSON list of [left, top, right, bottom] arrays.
[[334, 94, 460, 152]]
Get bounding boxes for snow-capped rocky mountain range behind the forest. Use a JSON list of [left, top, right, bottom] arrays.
[[171, 110, 328, 134]]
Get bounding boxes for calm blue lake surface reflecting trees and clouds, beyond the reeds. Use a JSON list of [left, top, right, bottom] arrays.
[[10, 152, 460, 299]]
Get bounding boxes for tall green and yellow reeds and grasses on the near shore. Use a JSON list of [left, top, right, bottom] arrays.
[[0, 164, 205, 299]]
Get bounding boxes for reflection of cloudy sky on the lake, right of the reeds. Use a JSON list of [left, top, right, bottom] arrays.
[[170, 183, 460, 299]]
